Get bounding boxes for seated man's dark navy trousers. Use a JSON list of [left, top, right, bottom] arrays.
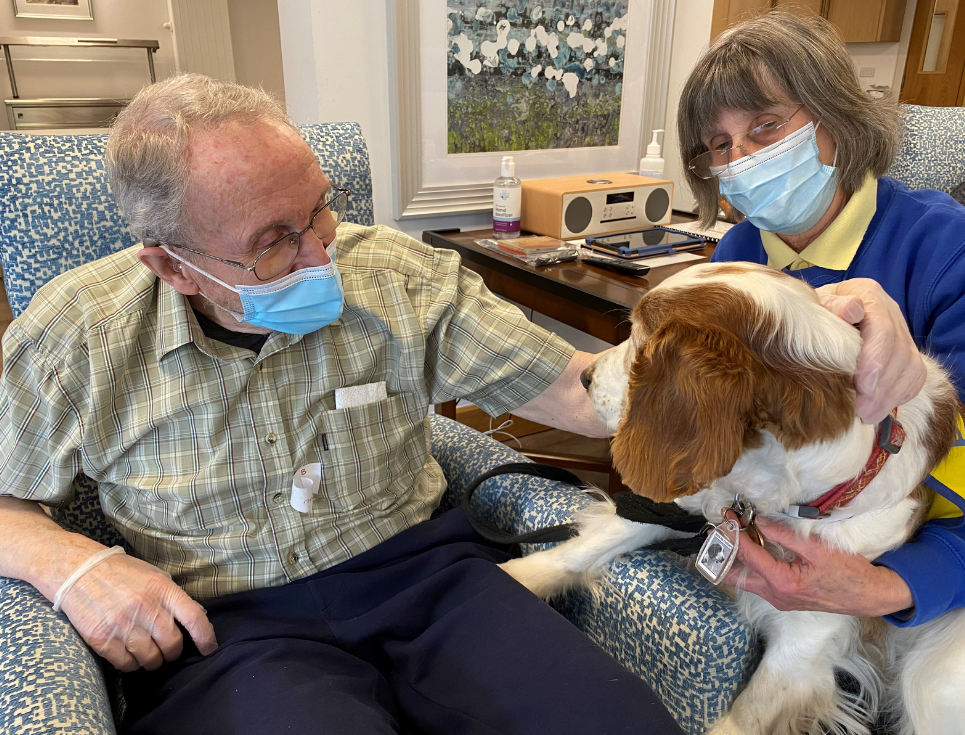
[[123, 510, 681, 735]]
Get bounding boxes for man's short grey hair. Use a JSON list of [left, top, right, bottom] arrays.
[[104, 74, 293, 242]]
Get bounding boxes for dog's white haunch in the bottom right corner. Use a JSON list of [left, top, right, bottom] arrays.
[[889, 610, 965, 735]]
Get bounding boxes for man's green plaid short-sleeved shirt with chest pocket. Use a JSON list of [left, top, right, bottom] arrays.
[[0, 225, 573, 599]]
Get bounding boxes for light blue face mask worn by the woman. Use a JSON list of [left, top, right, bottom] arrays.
[[711, 122, 838, 235]]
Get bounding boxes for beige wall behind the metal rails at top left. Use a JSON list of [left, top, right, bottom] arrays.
[[0, 0, 175, 130]]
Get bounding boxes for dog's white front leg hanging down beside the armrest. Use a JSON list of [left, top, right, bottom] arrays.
[[710, 595, 877, 735]]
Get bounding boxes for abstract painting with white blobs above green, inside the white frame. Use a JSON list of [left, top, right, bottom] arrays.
[[446, 0, 628, 154]]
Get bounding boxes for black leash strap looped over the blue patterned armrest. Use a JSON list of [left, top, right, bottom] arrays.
[[462, 462, 706, 556]]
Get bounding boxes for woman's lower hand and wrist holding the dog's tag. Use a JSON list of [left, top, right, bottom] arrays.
[[725, 518, 914, 617]]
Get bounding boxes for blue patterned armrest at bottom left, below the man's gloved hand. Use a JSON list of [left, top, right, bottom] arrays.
[[0, 577, 115, 735]]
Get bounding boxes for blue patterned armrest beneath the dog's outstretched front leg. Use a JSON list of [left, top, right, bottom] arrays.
[[431, 416, 758, 735]]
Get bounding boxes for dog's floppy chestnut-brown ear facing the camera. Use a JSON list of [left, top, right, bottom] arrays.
[[612, 321, 766, 501]]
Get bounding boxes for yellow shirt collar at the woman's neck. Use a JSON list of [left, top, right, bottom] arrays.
[[761, 174, 878, 271]]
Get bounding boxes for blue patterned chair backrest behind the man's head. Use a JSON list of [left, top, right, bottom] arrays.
[[0, 123, 375, 316]]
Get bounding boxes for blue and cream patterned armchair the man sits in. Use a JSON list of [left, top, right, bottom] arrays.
[[0, 123, 756, 735]]
